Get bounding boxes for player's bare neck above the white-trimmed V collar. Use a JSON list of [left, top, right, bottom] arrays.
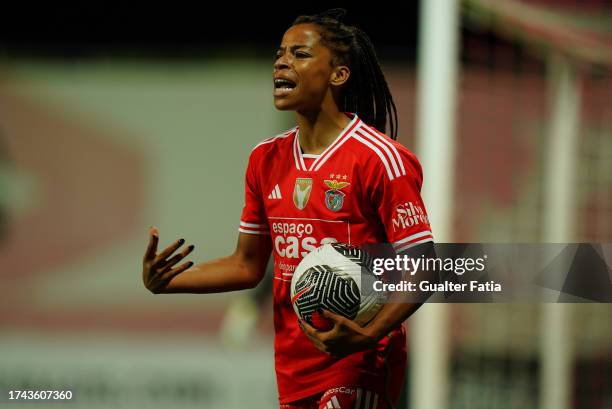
[[297, 109, 351, 155]]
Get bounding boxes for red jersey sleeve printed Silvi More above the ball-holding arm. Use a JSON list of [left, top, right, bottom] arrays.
[[370, 145, 433, 253]]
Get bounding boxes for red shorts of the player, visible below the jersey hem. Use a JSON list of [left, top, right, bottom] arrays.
[[280, 386, 399, 409]]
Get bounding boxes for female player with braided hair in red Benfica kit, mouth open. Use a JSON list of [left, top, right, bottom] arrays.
[[143, 9, 433, 409]]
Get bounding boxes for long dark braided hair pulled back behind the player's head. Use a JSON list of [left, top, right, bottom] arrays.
[[292, 9, 397, 139]]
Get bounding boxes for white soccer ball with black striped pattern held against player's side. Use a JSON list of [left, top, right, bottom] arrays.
[[291, 243, 384, 330]]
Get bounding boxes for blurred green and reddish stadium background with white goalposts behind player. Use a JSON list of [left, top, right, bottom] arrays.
[[0, 0, 612, 409]]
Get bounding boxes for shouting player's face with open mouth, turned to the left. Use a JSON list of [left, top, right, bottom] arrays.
[[274, 24, 334, 111]]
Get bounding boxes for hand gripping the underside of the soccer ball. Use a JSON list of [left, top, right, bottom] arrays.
[[298, 310, 376, 358]]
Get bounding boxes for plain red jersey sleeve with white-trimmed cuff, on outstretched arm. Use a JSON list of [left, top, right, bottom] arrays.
[[238, 151, 270, 234]]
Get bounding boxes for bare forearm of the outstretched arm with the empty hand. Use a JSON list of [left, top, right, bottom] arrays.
[[164, 255, 261, 294]]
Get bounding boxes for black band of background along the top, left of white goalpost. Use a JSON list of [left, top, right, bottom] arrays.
[[0, 2, 418, 59]]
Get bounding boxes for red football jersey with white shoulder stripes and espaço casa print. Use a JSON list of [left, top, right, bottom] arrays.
[[239, 114, 433, 403]]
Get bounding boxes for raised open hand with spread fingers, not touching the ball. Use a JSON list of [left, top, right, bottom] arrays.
[[142, 227, 194, 294]]
